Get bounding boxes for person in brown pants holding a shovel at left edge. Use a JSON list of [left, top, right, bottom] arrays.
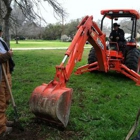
[[0, 26, 15, 135]]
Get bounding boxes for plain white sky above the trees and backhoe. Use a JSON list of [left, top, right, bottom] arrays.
[[42, 0, 140, 23]]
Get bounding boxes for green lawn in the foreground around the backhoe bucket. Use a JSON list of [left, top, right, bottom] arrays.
[[8, 49, 140, 140]]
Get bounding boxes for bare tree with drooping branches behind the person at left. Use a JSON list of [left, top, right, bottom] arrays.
[[0, 0, 66, 44]]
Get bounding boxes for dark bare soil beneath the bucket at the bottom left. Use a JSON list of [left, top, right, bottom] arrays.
[[0, 120, 82, 140]]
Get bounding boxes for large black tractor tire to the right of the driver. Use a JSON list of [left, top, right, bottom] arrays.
[[125, 48, 140, 73]]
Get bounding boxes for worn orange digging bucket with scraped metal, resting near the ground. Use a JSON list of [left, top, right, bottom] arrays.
[[29, 81, 73, 127]]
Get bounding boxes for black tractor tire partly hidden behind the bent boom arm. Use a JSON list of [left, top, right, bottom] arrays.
[[88, 47, 97, 64]]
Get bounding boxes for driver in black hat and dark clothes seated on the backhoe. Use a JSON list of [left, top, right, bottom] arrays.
[[109, 23, 126, 50]]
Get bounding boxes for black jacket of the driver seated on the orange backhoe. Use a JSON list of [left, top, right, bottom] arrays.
[[109, 28, 125, 42]]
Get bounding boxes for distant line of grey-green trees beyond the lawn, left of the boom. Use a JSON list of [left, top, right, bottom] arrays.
[[11, 19, 81, 41]]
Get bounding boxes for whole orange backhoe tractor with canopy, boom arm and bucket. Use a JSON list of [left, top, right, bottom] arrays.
[[29, 9, 140, 127]]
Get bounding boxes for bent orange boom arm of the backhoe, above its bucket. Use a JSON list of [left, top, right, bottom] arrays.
[[55, 16, 107, 86]]
